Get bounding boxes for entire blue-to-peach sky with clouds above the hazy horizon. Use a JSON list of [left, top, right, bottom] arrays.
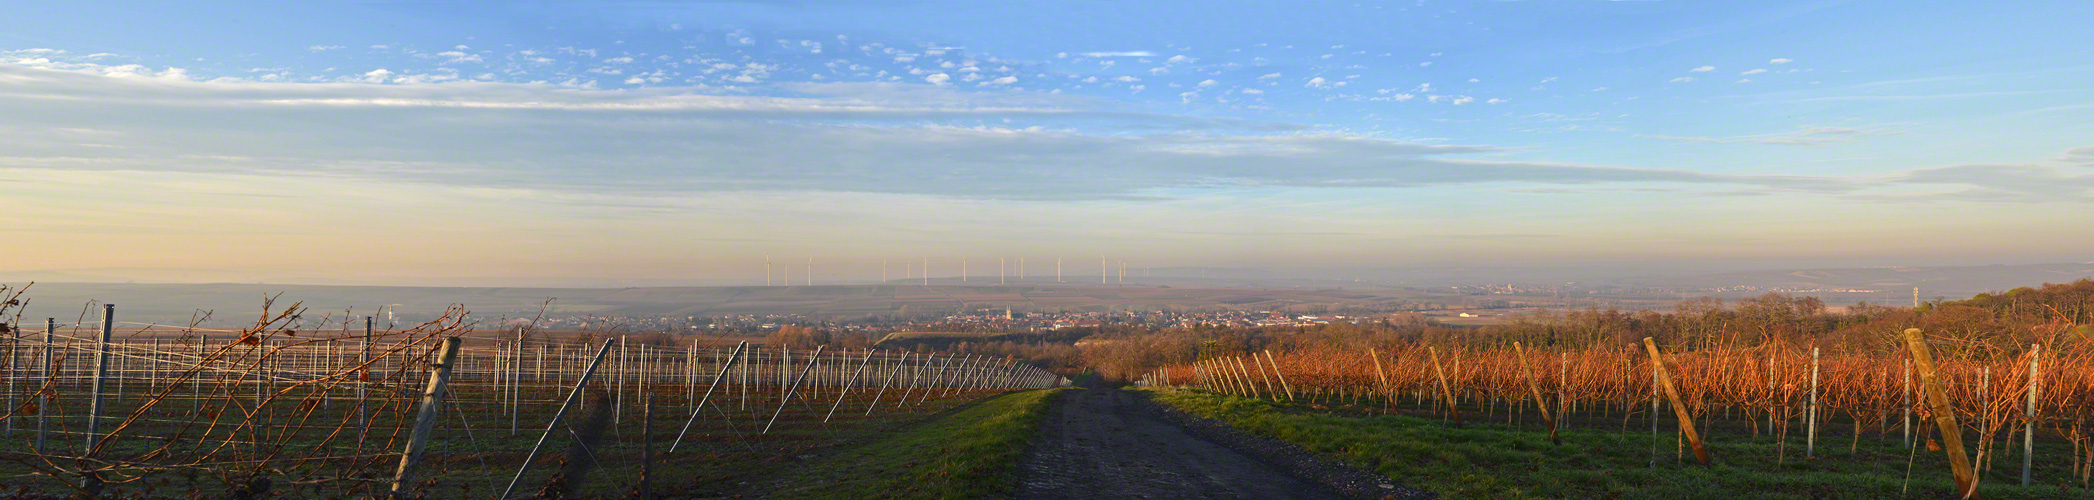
[[0, 0, 2094, 285]]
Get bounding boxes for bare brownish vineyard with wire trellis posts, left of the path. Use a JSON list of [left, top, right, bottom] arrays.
[[0, 291, 1064, 498]]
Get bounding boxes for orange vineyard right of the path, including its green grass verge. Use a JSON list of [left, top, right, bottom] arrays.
[[1118, 280, 2094, 498]]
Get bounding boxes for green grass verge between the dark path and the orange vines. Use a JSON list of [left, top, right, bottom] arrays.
[[1156, 391, 2088, 500]]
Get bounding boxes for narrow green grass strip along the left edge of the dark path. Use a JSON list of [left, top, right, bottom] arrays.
[[768, 389, 1060, 498]]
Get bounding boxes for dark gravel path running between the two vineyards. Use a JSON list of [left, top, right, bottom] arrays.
[[1018, 389, 1432, 500]]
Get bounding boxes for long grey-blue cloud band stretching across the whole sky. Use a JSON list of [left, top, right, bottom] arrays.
[[0, 65, 2088, 201]]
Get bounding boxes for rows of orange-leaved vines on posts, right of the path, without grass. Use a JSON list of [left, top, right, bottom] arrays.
[[1137, 328, 2094, 495]]
